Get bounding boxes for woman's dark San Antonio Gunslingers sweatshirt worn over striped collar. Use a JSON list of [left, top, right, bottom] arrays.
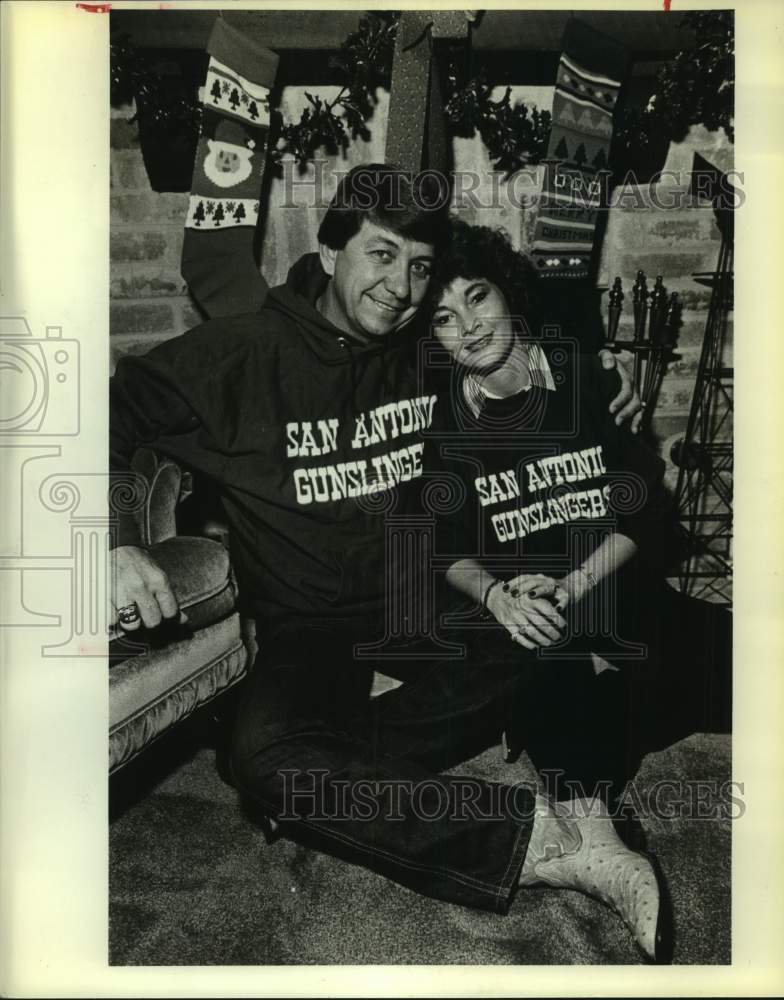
[[436, 347, 672, 628]]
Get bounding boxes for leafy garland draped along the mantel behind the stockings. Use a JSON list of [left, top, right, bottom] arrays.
[[111, 11, 734, 179]]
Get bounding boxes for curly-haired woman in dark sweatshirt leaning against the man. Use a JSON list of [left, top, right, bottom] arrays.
[[428, 221, 669, 960]]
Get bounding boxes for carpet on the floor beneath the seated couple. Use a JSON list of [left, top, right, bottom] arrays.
[[109, 734, 731, 966]]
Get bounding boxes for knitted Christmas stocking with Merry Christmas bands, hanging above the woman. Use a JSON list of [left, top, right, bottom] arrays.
[[531, 20, 626, 278]]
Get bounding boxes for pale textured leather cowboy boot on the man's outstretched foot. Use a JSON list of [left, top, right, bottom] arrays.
[[520, 795, 671, 963]]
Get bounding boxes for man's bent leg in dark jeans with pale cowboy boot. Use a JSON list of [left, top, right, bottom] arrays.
[[233, 625, 666, 960]]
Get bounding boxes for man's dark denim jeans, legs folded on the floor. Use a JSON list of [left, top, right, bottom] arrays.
[[225, 621, 636, 912]]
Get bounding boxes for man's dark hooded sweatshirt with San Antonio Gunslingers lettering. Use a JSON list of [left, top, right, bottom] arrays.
[[110, 254, 436, 620]]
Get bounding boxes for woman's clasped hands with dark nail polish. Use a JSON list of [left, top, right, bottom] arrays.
[[487, 575, 566, 649]]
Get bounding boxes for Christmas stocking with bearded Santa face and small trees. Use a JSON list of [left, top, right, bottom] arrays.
[[182, 17, 278, 317]]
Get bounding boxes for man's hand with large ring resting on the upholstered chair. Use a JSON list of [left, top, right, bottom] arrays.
[[109, 545, 179, 632]]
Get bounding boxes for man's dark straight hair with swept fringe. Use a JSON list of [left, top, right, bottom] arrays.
[[318, 163, 449, 253]]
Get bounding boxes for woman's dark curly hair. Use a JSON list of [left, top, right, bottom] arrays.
[[423, 219, 539, 332]]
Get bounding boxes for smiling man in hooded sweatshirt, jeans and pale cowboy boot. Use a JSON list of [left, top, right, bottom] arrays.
[[111, 165, 658, 956]]
